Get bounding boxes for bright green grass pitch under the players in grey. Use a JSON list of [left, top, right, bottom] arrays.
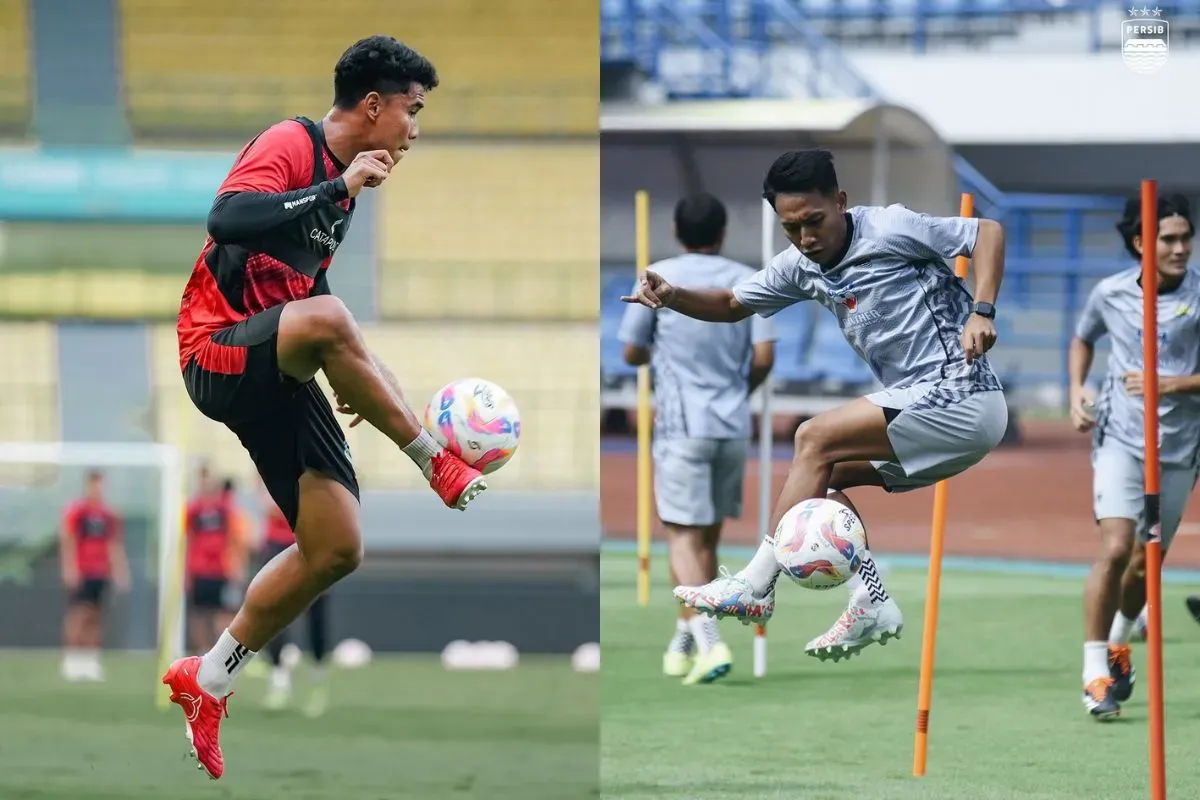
[[601, 555, 1200, 800]]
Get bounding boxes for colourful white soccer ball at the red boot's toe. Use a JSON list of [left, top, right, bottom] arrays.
[[425, 378, 521, 473]]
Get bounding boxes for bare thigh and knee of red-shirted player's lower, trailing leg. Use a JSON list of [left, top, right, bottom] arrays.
[[295, 469, 362, 578]]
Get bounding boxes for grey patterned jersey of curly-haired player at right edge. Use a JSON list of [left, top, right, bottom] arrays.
[[1075, 267, 1200, 467]]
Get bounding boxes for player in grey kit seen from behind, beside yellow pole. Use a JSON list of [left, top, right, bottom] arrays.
[[619, 194, 775, 685]]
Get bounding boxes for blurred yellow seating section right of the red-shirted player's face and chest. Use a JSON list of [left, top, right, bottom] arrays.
[[379, 142, 600, 320]]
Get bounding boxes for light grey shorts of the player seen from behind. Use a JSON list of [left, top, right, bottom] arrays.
[[654, 439, 750, 528]]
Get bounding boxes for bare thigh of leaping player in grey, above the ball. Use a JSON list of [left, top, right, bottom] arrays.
[[794, 397, 895, 465]]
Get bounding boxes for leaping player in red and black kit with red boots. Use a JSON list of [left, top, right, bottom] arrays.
[[163, 36, 486, 778]]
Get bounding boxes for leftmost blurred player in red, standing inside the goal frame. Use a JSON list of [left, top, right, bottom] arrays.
[[59, 470, 130, 681]]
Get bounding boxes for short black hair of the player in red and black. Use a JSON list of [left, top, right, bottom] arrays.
[[334, 36, 438, 109]]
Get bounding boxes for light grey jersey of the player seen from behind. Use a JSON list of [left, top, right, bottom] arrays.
[[618, 253, 775, 439]]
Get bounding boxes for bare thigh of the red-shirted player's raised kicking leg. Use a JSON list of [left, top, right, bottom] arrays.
[[275, 295, 361, 384]]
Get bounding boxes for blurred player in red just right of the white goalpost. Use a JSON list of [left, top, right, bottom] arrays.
[[185, 467, 247, 652]]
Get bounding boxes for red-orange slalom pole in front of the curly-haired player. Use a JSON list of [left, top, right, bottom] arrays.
[[1141, 181, 1166, 800]]
